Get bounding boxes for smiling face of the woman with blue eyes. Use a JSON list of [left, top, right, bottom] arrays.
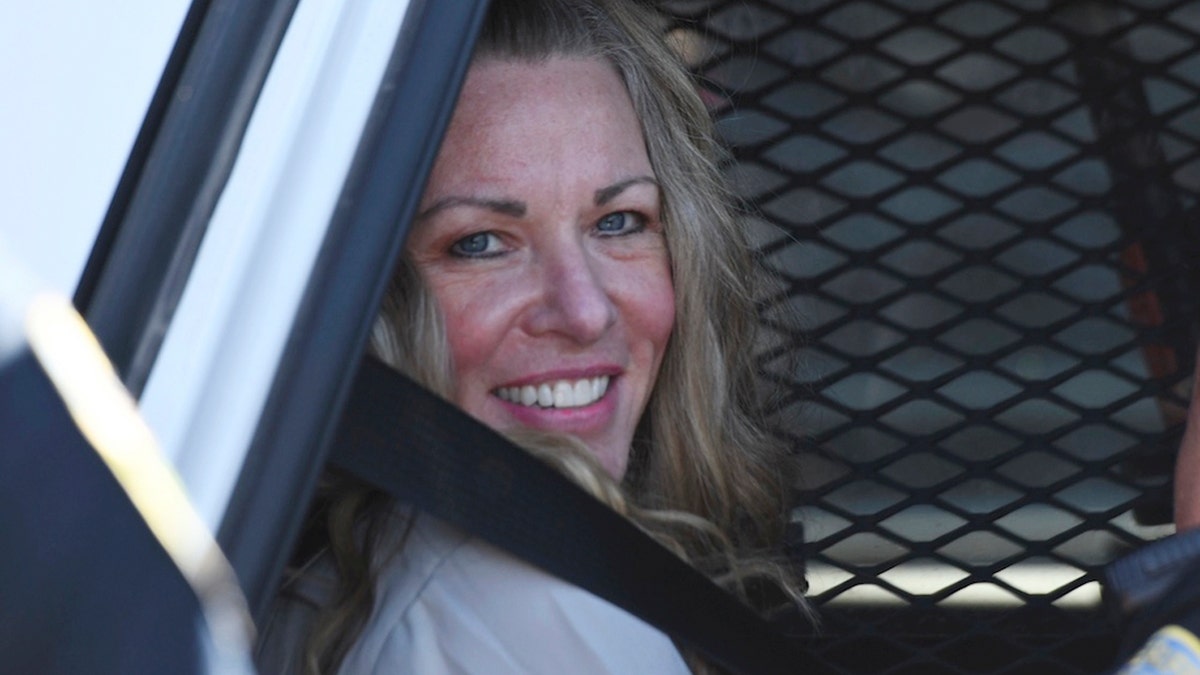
[[408, 59, 674, 479]]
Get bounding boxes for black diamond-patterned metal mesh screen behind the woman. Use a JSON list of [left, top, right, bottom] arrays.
[[660, 0, 1200, 674]]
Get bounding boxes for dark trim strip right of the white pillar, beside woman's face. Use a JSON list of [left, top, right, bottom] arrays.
[[217, 0, 487, 620]]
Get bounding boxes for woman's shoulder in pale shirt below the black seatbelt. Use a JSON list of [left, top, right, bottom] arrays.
[[343, 516, 688, 674]]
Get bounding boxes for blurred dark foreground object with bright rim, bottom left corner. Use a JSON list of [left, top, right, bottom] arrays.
[[0, 243, 253, 674]]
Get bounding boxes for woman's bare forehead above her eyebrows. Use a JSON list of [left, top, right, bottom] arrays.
[[430, 58, 652, 191]]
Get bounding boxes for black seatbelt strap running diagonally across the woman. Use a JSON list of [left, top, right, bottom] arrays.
[[330, 358, 821, 675]]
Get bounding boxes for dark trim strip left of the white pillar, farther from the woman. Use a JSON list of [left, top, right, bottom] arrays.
[[74, 0, 299, 396]]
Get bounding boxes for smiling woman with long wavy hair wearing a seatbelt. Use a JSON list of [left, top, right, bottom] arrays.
[[260, 0, 799, 673]]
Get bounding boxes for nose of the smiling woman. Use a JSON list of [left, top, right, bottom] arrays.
[[528, 241, 617, 345]]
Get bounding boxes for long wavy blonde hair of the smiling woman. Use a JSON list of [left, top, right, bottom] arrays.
[[295, 0, 808, 673]]
